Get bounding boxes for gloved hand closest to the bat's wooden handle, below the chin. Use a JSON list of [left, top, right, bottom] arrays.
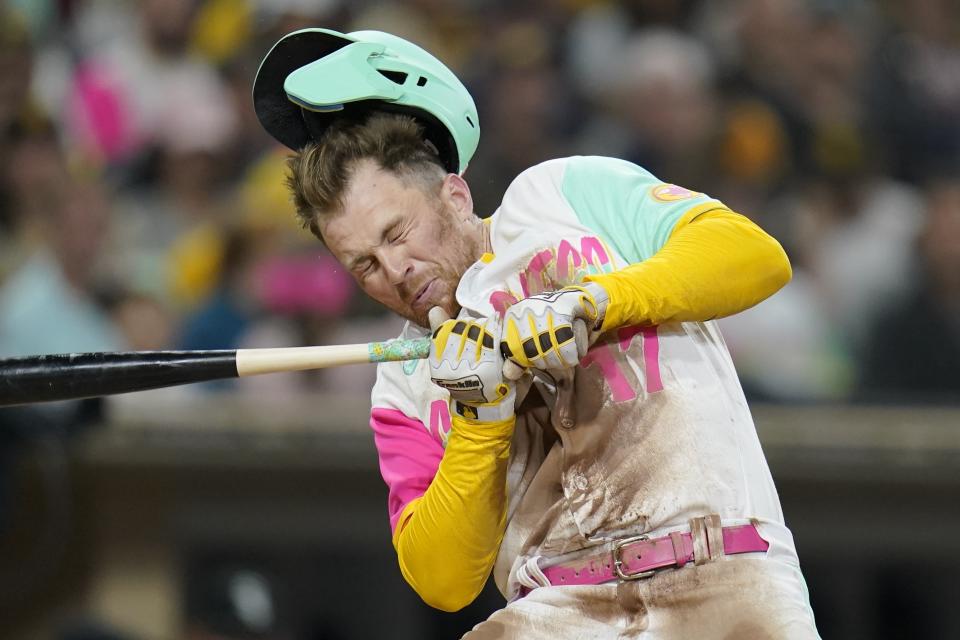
[[429, 307, 516, 422]]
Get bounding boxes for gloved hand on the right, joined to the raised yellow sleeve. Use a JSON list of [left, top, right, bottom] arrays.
[[501, 282, 608, 377]]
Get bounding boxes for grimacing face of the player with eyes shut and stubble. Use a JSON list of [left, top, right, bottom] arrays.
[[320, 161, 483, 327]]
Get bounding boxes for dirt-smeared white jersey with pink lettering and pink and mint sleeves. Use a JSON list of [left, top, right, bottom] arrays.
[[371, 157, 799, 598]]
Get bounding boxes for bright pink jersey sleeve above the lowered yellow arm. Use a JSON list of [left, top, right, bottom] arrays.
[[370, 407, 443, 532]]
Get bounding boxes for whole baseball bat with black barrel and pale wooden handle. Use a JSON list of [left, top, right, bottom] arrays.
[[0, 337, 430, 407]]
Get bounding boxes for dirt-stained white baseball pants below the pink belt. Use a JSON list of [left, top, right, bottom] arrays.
[[464, 524, 820, 640]]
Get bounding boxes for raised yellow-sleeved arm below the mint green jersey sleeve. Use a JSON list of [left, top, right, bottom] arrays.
[[586, 211, 792, 331]]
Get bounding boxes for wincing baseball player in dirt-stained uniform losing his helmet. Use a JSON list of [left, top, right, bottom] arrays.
[[254, 29, 818, 640]]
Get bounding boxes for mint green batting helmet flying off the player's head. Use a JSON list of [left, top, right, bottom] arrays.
[[253, 29, 480, 173]]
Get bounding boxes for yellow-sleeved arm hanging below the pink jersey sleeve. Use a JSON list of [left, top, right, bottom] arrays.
[[394, 416, 515, 611]]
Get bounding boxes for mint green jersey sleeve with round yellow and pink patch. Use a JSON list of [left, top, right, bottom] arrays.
[[561, 156, 723, 263]]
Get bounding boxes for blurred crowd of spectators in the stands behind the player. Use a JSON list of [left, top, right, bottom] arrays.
[[0, 0, 960, 638]]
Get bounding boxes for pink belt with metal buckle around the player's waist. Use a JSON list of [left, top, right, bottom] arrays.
[[521, 524, 770, 594]]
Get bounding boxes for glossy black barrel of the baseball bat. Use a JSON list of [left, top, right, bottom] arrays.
[[0, 350, 237, 407]]
